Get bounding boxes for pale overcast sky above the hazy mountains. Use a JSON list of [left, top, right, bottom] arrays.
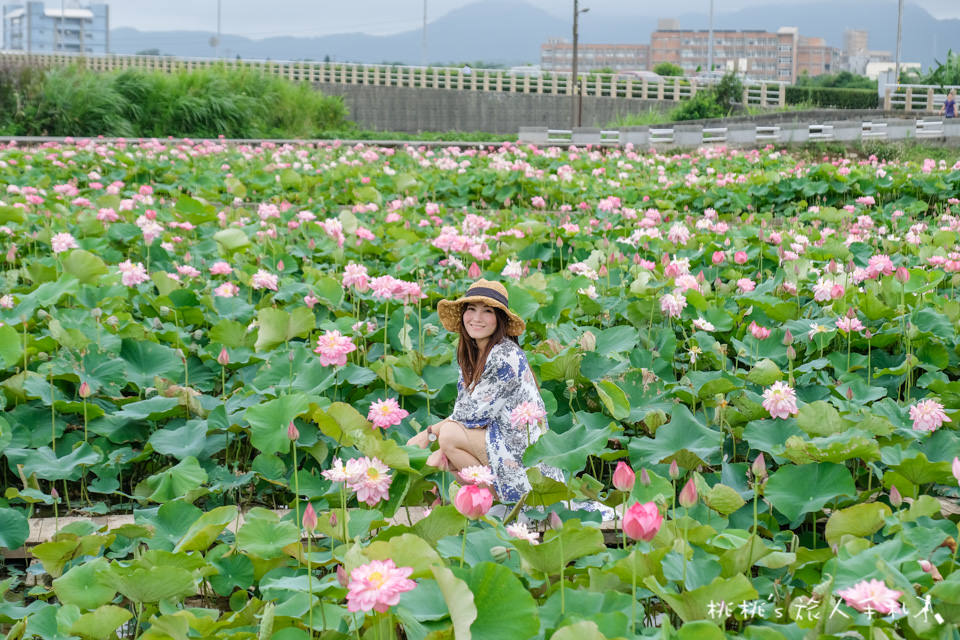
[[101, 0, 960, 38]]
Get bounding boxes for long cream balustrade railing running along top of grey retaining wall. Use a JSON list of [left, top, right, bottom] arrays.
[[0, 51, 786, 107]]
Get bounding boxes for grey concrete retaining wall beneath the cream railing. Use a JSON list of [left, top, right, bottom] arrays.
[[314, 83, 676, 134]]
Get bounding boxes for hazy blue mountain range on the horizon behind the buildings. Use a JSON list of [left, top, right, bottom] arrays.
[[110, 0, 960, 68]]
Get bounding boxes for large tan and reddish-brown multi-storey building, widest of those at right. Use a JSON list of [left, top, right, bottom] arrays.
[[650, 27, 798, 82]]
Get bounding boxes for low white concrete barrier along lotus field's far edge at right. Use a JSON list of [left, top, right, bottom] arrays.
[[519, 118, 960, 147]]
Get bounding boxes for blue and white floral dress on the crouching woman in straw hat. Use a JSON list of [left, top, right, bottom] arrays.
[[450, 339, 564, 502]]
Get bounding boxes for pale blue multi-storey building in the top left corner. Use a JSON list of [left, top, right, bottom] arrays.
[[3, 1, 110, 53]]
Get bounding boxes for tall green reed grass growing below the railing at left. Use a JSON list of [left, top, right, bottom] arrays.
[[0, 66, 349, 138]]
